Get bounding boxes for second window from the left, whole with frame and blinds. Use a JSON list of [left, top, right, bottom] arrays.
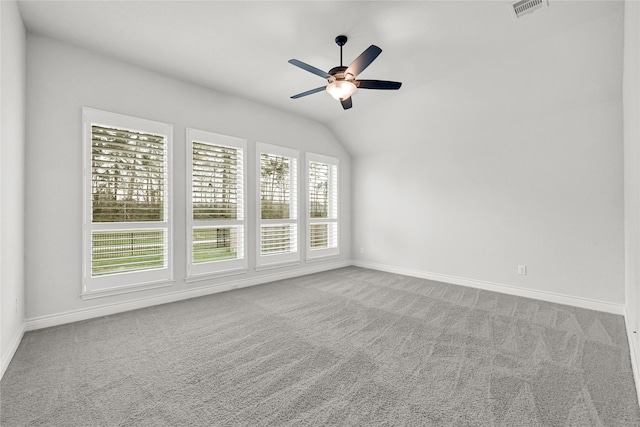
[[187, 129, 247, 279]]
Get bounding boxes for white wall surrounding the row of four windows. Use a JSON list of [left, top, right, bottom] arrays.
[[26, 33, 351, 327]]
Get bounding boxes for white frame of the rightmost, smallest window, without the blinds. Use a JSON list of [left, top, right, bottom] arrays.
[[305, 153, 340, 261]]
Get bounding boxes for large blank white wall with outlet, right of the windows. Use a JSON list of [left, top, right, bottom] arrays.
[[340, 3, 624, 312]]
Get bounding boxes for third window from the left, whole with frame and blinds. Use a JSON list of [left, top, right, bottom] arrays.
[[257, 143, 300, 267]]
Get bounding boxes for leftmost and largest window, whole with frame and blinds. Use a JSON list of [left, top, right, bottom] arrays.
[[82, 108, 173, 296]]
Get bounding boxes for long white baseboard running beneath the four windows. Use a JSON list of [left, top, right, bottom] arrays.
[[26, 260, 351, 332]]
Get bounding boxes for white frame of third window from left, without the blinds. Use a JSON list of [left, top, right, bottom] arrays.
[[255, 142, 301, 270]]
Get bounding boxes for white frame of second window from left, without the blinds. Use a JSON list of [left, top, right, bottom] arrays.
[[186, 128, 249, 282]]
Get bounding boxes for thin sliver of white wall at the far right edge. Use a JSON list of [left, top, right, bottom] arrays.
[[623, 1, 640, 385]]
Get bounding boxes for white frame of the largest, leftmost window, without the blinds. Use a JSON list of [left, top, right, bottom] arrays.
[[80, 107, 174, 299]]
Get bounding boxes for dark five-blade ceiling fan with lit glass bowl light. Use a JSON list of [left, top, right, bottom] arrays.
[[289, 36, 402, 110]]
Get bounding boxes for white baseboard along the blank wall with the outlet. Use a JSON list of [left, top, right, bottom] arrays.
[[352, 260, 624, 315]]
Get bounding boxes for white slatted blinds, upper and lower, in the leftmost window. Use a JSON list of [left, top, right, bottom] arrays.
[[91, 125, 167, 277]]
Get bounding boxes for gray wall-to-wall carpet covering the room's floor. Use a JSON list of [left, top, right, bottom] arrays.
[[0, 267, 640, 426]]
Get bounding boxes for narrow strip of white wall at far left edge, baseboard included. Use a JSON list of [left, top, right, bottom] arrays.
[[0, 1, 26, 377]]
